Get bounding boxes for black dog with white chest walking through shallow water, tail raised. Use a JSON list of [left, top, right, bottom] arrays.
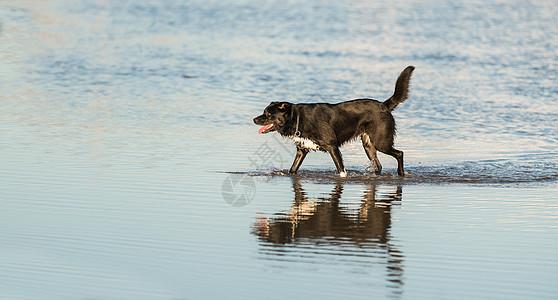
[[254, 66, 415, 177]]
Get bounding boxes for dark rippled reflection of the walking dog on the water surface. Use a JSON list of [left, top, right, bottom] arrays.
[[253, 177, 404, 286]]
